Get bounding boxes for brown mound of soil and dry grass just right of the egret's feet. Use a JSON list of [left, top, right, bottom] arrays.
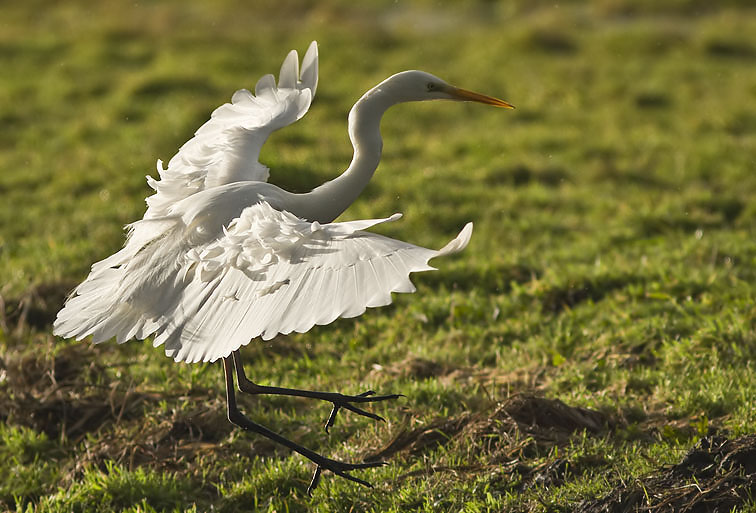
[[366, 394, 615, 492]]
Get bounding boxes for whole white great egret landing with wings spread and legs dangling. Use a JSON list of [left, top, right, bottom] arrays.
[[54, 41, 512, 491]]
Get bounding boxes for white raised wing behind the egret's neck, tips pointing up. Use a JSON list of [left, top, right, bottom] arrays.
[[145, 41, 318, 219]]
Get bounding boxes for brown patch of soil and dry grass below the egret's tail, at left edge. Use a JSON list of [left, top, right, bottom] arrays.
[[0, 336, 236, 481]]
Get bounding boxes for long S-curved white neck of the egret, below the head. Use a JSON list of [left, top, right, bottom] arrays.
[[296, 87, 396, 223]]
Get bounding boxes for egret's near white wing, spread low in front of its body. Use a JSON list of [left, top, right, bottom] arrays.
[[148, 203, 472, 362]]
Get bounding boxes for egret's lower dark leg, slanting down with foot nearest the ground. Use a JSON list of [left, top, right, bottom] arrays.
[[223, 357, 386, 494]]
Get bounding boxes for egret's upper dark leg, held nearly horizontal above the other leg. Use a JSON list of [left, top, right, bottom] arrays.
[[233, 350, 402, 433]]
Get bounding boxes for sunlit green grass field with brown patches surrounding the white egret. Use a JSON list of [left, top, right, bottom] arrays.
[[0, 0, 756, 512]]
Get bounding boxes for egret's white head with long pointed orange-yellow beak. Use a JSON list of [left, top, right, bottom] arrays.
[[376, 70, 514, 109]]
